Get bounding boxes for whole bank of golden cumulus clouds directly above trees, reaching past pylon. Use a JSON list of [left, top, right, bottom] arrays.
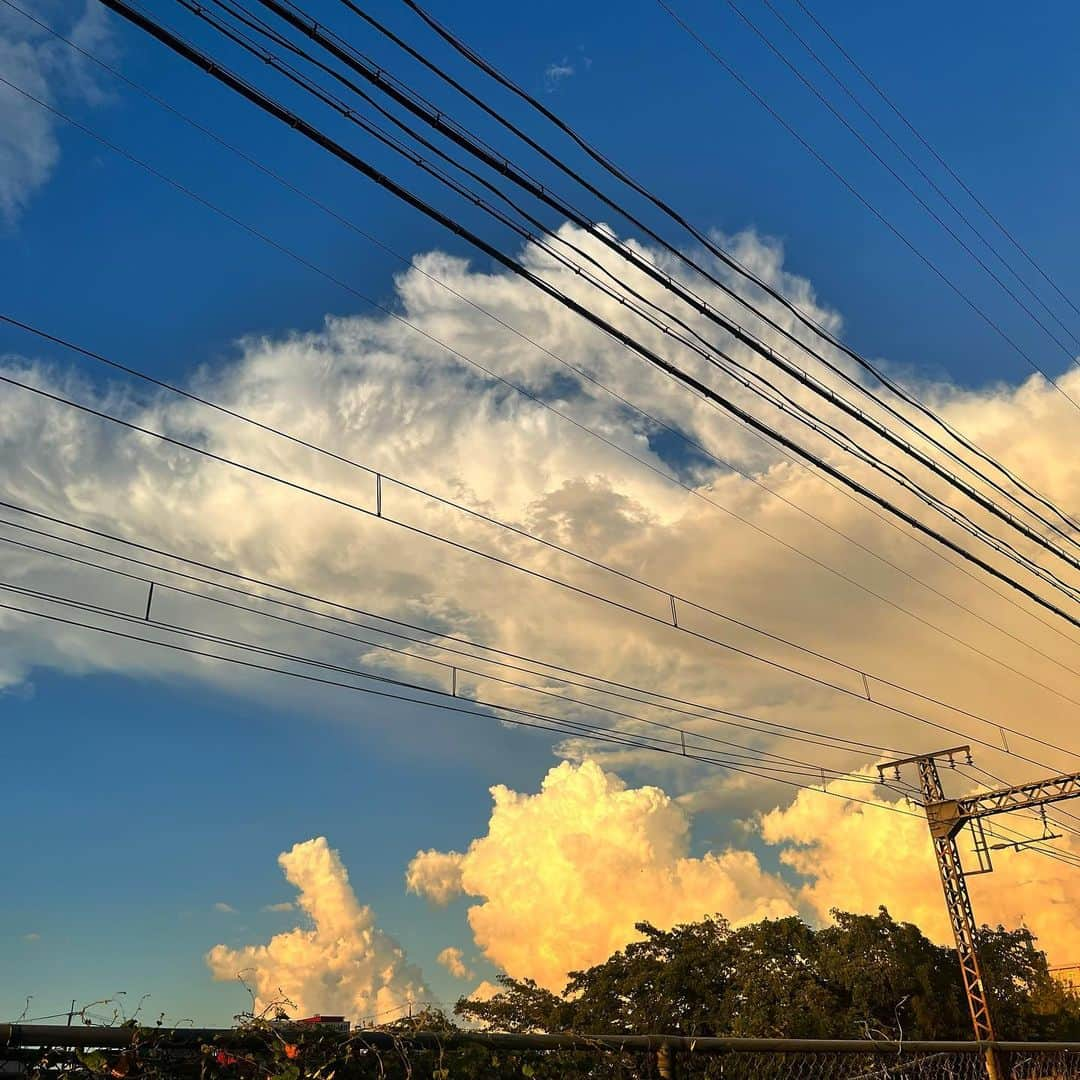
[[410, 761, 1080, 996]]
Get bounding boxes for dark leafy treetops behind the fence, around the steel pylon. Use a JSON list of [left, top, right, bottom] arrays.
[[456, 908, 1080, 1039]]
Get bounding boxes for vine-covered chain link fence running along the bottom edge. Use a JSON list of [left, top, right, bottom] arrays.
[[0, 1024, 1080, 1080]]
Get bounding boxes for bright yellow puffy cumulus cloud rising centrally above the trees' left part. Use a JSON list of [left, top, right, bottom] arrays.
[[407, 761, 794, 989]]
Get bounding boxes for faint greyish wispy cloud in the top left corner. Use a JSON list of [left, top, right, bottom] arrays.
[[0, 0, 109, 222]]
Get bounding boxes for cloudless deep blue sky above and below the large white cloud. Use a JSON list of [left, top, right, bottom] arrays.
[[0, 0, 1080, 1022]]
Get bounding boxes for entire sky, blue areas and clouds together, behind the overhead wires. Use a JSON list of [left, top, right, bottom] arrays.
[[0, 0, 1080, 1023]]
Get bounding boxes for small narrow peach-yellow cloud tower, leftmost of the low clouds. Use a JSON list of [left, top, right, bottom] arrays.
[[206, 836, 428, 1018]]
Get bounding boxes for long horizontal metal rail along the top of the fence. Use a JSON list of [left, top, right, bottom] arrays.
[[0, 1024, 1080, 1058]]
